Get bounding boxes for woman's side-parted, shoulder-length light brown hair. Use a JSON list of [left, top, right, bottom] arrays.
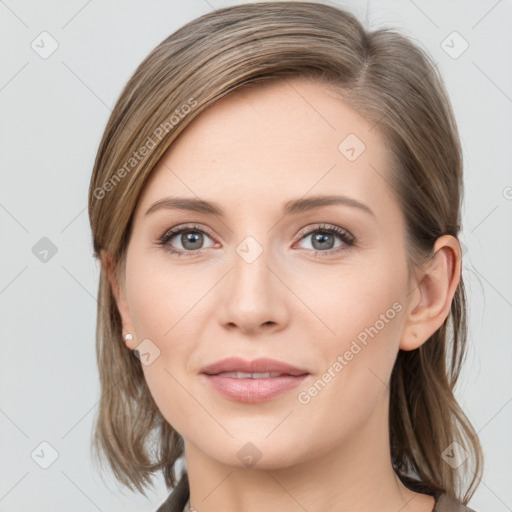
[[89, 1, 483, 504]]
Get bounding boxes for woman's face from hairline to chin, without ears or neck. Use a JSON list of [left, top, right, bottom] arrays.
[[118, 78, 415, 468]]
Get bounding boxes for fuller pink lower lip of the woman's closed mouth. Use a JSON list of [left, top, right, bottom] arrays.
[[203, 374, 308, 404]]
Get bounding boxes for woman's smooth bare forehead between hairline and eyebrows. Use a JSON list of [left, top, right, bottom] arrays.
[[137, 77, 397, 220]]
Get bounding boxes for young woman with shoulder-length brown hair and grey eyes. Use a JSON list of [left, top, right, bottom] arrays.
[[89, 2, 482, 512]]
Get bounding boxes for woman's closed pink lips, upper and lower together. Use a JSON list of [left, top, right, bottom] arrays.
[[202, 357, 309, 404]]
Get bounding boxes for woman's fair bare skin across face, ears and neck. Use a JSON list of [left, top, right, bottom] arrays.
[[103, 78, 461, 512]]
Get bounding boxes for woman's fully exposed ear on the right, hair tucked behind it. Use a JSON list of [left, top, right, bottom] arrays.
[[400, 235, 462, 351]]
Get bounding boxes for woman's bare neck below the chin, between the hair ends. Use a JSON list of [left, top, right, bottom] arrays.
[[185, 392, 434, 512]]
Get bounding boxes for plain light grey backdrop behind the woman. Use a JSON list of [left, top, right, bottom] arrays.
[[0, 0, 512, 512]]
